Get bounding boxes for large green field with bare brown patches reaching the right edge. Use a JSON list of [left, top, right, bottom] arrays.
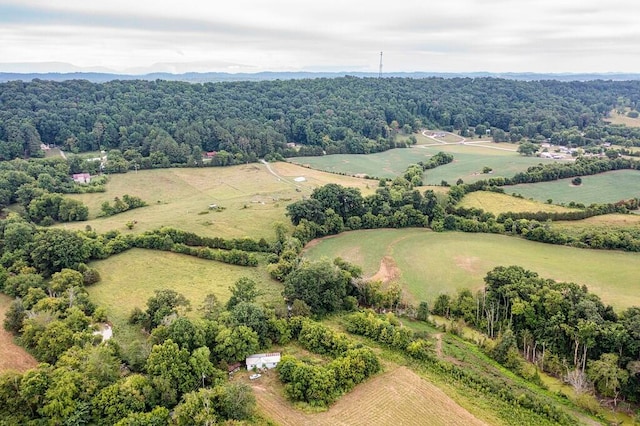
[[305, 228, 640, 309]]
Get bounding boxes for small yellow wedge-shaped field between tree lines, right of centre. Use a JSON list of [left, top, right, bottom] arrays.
[[459, 191, 572, 215]]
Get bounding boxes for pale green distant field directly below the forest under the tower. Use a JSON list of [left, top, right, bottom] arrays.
[[289, 135, 552, 185]]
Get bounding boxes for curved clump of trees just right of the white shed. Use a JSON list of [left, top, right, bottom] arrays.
[[277, 317, 381, 407]]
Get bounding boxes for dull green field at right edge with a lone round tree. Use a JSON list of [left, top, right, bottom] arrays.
[[504, 170, 640, 205]]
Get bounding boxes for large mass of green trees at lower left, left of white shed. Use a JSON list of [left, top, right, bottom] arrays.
[[0, 282, 260, 425]]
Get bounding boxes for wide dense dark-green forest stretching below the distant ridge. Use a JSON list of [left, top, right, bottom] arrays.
[[0, 77, 640, 166]]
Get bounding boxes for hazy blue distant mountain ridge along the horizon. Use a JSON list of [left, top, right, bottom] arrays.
[[0, 70, 640, 83]]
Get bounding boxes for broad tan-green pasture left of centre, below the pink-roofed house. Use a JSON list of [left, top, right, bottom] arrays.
[[59, 163, 377, 239]]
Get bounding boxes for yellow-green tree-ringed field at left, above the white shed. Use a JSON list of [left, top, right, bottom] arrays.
[[88, 249, 282, 322]]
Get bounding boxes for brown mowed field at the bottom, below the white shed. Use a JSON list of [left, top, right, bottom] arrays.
[[250, 367, 486, 426]]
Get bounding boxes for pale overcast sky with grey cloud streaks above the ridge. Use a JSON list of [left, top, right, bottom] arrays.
[[0, 0, 640, 73]]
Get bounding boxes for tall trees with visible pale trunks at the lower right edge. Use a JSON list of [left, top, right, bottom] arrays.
[[432, 266, 640, 402]]
